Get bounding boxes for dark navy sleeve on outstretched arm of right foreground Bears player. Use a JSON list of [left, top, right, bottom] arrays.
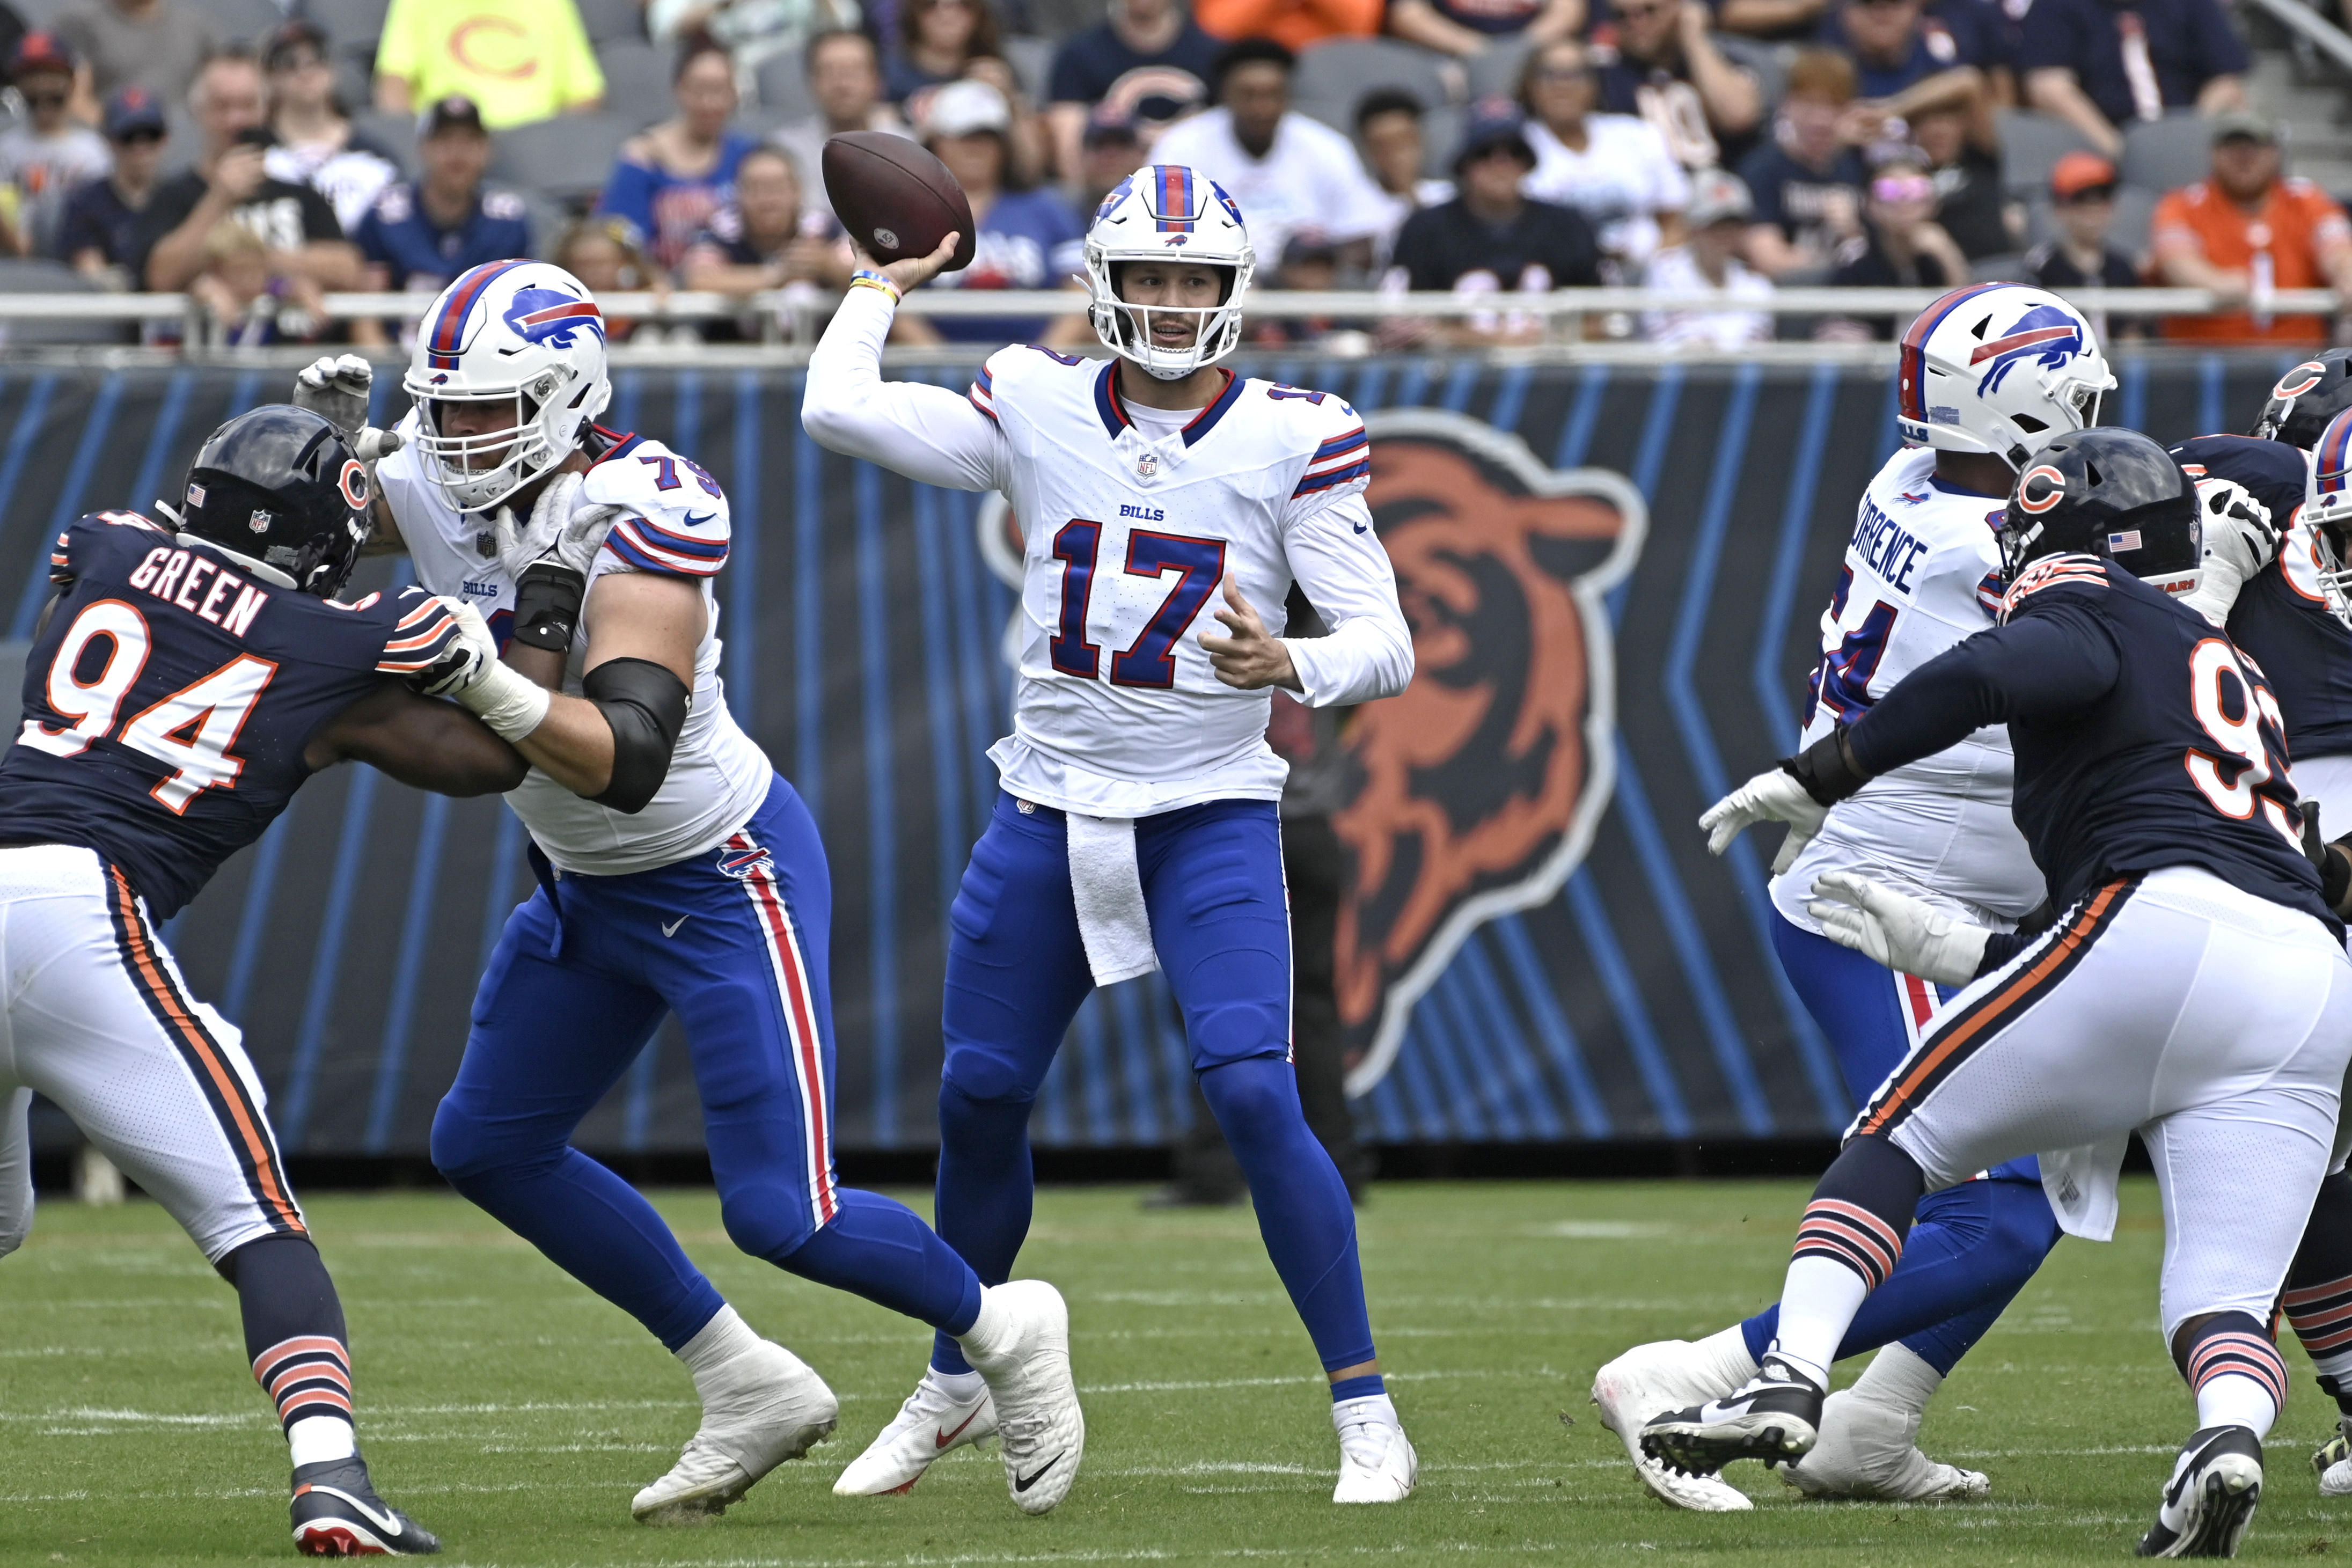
[[1847, 604, 2121, 778]]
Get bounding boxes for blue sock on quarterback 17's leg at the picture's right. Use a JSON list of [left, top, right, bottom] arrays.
[[1199, 1056, 1374, 1373]]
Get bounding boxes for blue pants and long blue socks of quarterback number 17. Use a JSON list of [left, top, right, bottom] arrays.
[[932, 795, 1374, 1373]]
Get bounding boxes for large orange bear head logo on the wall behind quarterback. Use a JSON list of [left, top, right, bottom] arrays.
[[1333, 409, 1646, 1095]]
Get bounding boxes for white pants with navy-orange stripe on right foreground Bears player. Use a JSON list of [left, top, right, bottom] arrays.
[[1856, 868, 2352, 1342]]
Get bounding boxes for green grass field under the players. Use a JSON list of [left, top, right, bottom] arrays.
[[0, 1183, 2352, 1568]]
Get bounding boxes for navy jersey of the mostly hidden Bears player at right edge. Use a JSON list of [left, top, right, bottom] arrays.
[[2173, 435, 2352, 757]]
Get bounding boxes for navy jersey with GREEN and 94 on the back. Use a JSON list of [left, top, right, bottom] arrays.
[[0, 512, 456, 917]]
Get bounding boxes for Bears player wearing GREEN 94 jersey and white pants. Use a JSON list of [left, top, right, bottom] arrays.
[[0, 407, 522, 1556]]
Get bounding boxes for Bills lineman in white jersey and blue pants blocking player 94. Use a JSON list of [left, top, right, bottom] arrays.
[[287, 261, 1085, 1523]]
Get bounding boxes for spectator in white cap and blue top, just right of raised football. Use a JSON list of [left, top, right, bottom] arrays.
[[894, 78, 1094, 348]]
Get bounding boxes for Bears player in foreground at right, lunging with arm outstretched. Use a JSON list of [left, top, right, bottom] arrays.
[[1644, 430, 2352, 1556]]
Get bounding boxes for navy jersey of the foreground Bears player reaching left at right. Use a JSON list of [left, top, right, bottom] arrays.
[[1847, 555, 2342, 938]]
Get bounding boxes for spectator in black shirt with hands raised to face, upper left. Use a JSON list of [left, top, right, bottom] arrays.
[[131, 54, 360, 294]]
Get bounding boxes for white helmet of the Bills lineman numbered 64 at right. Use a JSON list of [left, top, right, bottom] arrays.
[[1896, 282, 2114, 470]]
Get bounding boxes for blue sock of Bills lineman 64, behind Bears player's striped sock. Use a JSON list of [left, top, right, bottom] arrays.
[[1740, 1178, 2061, 1375]]
